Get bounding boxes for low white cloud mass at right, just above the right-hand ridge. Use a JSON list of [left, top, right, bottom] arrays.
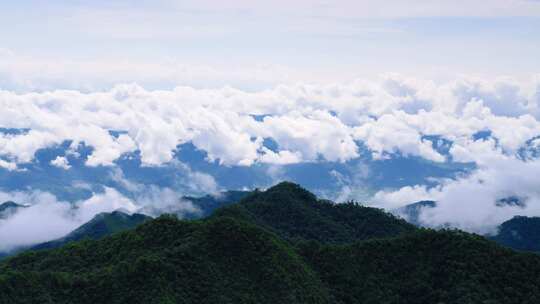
[[374, 145, 540, 234]]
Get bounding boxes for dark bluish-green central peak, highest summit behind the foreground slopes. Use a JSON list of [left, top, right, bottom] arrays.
[[214, 182, 416, 243]]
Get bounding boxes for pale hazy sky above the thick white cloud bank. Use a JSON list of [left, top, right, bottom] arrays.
[[0, 0, 540, 90]]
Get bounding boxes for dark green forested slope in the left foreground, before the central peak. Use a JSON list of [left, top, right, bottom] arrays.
[[0, 216, 331, 304]]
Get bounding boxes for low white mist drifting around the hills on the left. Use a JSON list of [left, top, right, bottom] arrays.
[[0, 185, 205, 252]]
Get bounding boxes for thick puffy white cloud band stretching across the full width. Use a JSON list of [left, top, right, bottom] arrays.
[[0, 75, 540, 170]]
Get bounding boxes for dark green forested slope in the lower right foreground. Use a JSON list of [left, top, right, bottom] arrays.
[[301, 230, 540, 304]]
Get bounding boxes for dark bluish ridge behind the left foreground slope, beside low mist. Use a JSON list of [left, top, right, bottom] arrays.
[[30, 211, 151, 250]]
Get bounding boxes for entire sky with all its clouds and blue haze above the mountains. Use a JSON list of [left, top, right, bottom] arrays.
[[0, 0, 540, 251]]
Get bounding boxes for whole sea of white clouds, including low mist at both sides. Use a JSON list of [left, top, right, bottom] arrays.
[[0, 75, 540, 249]]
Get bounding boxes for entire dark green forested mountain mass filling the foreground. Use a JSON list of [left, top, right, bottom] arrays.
[[0, 183, 540, 304]]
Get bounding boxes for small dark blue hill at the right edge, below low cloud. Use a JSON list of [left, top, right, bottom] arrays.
[[491, 216, 540, 253]]
